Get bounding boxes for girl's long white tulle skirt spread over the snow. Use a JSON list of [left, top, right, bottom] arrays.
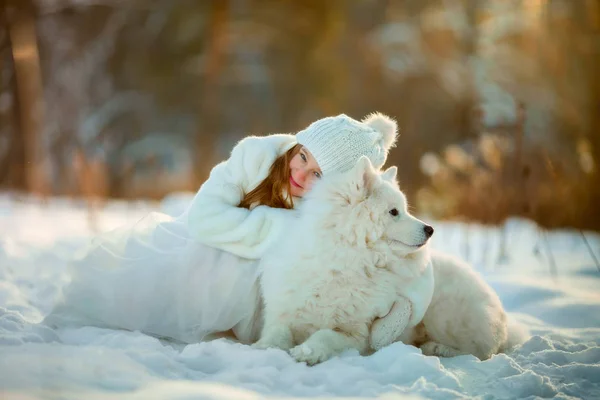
[[45, 213, 262, 343]]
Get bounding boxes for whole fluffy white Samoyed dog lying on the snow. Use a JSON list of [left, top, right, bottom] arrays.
[[254, 158, 526, 364]]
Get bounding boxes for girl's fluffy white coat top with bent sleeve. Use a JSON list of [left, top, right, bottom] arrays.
[[187, 134, 296, 259]]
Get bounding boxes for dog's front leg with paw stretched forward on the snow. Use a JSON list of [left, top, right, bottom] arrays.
[[290, 328, 368, 365]]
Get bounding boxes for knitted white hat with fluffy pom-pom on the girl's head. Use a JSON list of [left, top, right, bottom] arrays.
[[296, 113, 398, 175]]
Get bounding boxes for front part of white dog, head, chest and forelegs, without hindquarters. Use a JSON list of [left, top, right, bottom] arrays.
[[254, 157, 433, 364]]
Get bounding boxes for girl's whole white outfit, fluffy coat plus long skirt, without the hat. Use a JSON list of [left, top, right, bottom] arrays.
[[45, 134, 296, 343]]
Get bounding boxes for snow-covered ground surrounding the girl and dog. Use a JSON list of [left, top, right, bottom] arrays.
[[0, 194, 600, 399]]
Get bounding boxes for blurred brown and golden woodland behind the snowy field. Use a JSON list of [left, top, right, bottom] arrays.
[[0, 0, 600, 230]]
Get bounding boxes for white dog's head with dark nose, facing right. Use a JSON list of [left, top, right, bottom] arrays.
[[305, 157, 433, 256]]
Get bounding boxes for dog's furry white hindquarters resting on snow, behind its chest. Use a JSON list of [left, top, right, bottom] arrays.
[[400, 252, 521, 360]]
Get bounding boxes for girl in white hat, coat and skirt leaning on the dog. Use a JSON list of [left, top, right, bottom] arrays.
[[45, 113, 397, 343]]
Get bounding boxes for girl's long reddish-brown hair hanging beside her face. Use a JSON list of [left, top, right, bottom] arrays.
[[238, 144, 302, 209]]
